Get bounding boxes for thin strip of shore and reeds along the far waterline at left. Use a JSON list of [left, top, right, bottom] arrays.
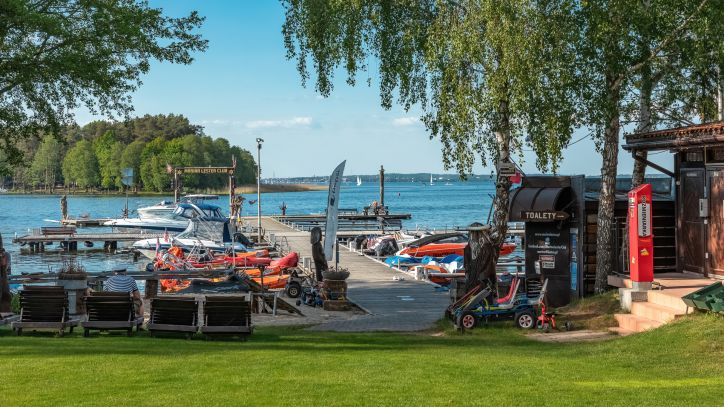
[[0, 184, 327, 197]]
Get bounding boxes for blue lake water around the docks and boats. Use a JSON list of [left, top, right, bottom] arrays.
[[0, 181, 495, 274]]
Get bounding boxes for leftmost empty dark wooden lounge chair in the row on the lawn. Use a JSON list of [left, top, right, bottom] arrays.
[[10, 287, 78, 336]]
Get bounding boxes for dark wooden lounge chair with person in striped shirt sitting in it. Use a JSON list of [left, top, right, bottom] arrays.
[[81, 291, 143, 337]]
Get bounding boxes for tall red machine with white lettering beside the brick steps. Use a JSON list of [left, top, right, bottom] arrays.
[[628, 184, 654, 289]]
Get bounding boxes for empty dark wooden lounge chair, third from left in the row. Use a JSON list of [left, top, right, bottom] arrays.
[[147, 295, 199, 339]]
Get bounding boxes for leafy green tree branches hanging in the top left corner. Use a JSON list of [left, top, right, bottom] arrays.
[[0, 0, 207, 169]]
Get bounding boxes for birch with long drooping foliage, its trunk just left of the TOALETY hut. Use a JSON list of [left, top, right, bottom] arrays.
[[282, 0, 577, 249]]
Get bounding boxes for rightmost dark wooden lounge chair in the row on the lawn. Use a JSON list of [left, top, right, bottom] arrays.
[[201, 296, 254, 340]]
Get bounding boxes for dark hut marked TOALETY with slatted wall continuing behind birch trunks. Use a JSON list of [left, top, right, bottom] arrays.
[[510, 175, 677, 304]]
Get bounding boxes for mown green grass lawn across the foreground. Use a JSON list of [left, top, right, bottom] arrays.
[[0, 315, 724, 407]]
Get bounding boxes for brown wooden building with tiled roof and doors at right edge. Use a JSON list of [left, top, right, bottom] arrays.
[[623, 121, 724, 278]]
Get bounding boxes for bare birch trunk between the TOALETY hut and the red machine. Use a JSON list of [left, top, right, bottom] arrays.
[[594, 78, 621, 293]]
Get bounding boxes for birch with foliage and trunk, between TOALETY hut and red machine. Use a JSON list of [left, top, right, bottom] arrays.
[[572, 0, 724, 292]]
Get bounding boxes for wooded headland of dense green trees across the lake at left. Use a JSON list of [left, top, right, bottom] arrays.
[[0, 114, 256, 192]]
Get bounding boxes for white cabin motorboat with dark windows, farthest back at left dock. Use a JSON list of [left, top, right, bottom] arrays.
[[104, 202, 224, 232]]
